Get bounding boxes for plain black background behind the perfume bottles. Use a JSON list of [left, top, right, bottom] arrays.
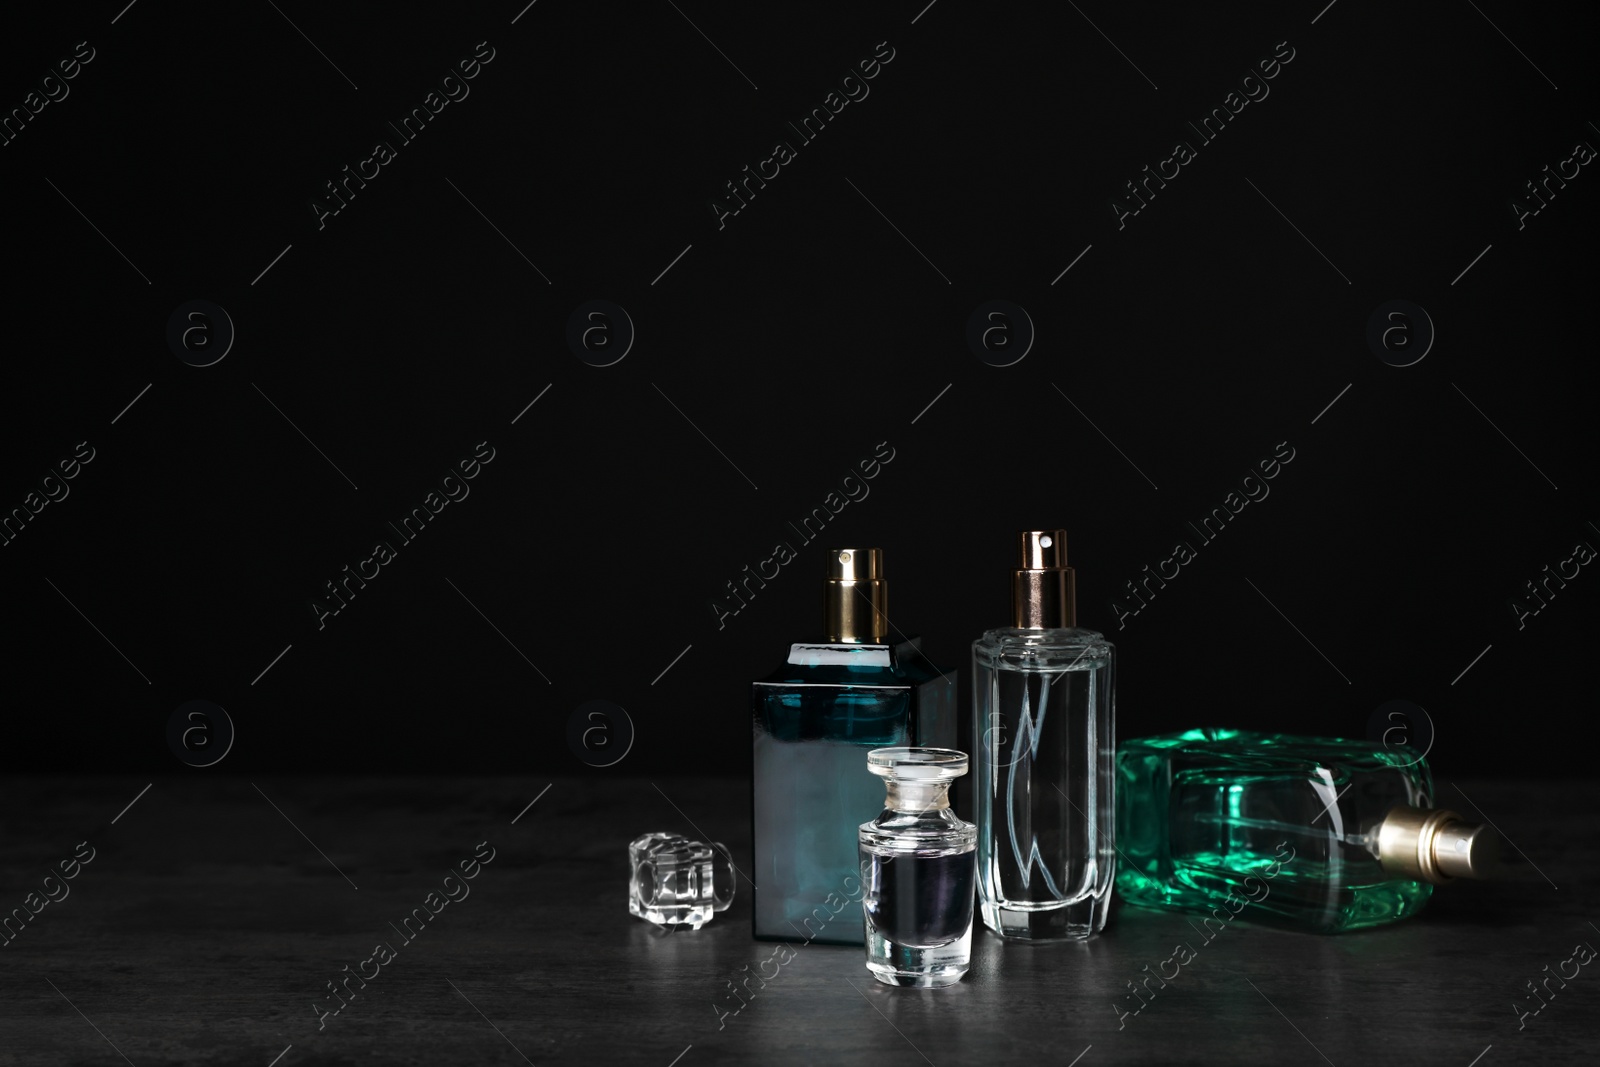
[[0, 0, 1600, 777]]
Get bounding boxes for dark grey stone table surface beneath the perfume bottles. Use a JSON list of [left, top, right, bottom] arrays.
[[0, 773, 1600, 1067]]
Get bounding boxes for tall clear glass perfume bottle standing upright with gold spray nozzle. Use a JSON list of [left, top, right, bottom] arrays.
[[973, 530, 1117, 941]]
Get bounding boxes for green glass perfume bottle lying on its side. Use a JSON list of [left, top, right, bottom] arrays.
[[1117, 728, 1499, 933]]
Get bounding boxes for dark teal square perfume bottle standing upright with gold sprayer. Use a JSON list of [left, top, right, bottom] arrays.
[[750, 549, 955, 945]]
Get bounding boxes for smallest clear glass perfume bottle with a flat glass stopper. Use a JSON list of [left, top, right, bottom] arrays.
[[859, 749, 978, 985]]
